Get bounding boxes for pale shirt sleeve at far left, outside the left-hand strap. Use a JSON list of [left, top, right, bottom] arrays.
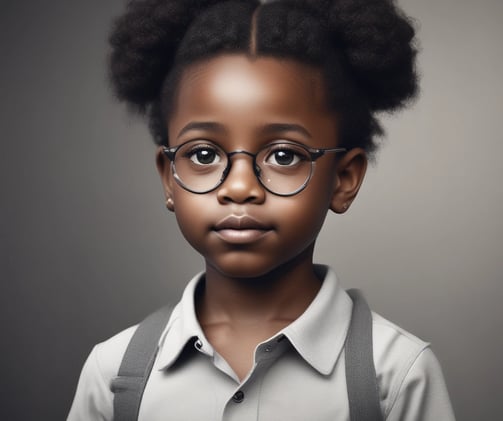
[[67, 345, 113, 421]]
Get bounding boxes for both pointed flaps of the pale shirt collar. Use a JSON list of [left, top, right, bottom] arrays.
[[155, 265, 352, 375]]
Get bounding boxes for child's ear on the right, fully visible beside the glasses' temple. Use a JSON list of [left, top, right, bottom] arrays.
[[330, 148, 367, 213]]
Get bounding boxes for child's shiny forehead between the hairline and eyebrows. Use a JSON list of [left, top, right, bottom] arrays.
[[173, 55, 328, 123]]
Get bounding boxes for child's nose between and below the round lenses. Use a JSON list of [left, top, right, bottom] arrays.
[[217, 151, 266, 204]]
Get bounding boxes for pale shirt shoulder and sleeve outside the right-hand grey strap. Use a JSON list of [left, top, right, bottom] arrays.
[[372, 313, 454, 420]]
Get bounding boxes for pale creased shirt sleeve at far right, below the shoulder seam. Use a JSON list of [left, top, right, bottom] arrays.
[[386, 347, 455, 421]]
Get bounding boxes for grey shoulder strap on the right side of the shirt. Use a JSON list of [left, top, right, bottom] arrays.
[[345, 289, 383, 421]]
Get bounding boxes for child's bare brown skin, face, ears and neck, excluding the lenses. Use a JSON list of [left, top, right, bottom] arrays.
[[157, 55, 367, 380]]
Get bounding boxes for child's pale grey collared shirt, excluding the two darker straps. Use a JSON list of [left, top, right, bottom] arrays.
[[68, 266, 454, 421]]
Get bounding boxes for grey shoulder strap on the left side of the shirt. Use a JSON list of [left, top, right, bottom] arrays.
[[111, 306, 172, 421]]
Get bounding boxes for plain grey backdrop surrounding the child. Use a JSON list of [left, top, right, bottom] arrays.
[[0, 0, 503, 420]]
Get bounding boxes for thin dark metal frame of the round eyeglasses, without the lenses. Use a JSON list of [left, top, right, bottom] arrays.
[[162, 140, 347, 197]]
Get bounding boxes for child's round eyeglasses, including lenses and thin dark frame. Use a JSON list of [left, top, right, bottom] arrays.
[[163, 140, 346, 196]]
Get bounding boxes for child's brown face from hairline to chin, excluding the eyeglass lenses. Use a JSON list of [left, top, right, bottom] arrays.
[[158, 55, 365, 278]]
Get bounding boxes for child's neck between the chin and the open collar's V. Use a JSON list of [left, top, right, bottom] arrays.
[[197, 246, 321, 325]]
